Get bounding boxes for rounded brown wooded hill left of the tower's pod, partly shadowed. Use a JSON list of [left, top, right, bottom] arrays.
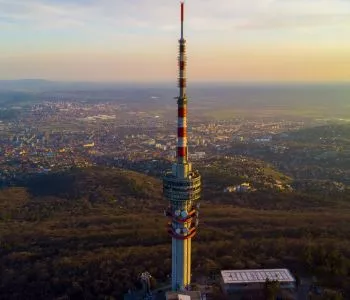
[[0, 167, 161, 220]]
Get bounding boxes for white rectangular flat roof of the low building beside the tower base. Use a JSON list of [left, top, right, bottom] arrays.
[[221, 269, 295, 283]]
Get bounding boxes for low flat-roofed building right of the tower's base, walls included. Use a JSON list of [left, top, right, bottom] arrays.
[[221, 269, 296, 299]]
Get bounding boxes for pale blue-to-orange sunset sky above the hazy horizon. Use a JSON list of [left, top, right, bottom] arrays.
[[0, 0, 350, 83]]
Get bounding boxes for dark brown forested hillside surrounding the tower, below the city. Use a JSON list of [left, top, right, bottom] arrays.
[[0, 168, 350, 299]]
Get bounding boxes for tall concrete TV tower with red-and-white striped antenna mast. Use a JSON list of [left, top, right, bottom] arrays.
[[163, 2, 201, 291]]
